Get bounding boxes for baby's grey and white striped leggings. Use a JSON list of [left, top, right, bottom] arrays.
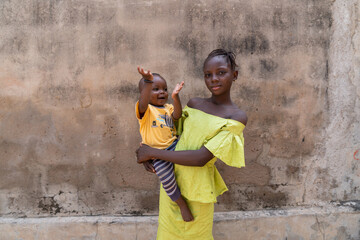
[[152, 140, 181, 201]]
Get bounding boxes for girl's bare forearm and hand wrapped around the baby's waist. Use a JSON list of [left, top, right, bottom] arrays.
[[136, 144, 214, 167]]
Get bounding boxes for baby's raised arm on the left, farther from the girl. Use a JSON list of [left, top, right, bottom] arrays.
[[138, 67, 154, 117]]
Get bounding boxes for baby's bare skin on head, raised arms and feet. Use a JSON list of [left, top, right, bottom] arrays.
[[138, 67, 194, 222]]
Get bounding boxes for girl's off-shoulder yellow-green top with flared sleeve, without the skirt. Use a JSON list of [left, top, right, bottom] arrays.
[[175, 106, 245, 203]]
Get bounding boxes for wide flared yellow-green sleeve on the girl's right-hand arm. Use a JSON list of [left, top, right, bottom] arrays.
[[204, 123, 245, 168]]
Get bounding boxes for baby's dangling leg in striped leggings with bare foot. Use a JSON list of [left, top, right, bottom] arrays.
[[153, 159, 194, 222]]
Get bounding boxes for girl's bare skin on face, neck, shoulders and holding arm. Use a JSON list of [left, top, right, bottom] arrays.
[[136, 56, 247, 167]]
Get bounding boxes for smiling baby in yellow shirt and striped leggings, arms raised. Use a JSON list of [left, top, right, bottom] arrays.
[[135, 67, 194, 222]]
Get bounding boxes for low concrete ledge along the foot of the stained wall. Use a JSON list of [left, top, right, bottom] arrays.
[[0, 202, 360, 240]]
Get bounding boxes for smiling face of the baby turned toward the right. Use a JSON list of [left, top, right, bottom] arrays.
[[150, 76, 169, 107]]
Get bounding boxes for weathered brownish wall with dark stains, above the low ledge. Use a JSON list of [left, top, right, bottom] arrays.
[[0, 0, 360, 216]]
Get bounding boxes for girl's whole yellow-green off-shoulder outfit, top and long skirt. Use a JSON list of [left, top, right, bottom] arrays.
[[157, 106, 245, 240]]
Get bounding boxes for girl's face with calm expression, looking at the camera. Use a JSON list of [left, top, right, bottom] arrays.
[[204, 55, 238, 95]]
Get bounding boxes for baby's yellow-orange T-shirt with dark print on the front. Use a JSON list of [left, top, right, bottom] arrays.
[[135, 102, 176, 149]]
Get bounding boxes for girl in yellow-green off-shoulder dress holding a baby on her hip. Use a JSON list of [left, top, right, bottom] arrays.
[[137, 49, 247, 240]]
